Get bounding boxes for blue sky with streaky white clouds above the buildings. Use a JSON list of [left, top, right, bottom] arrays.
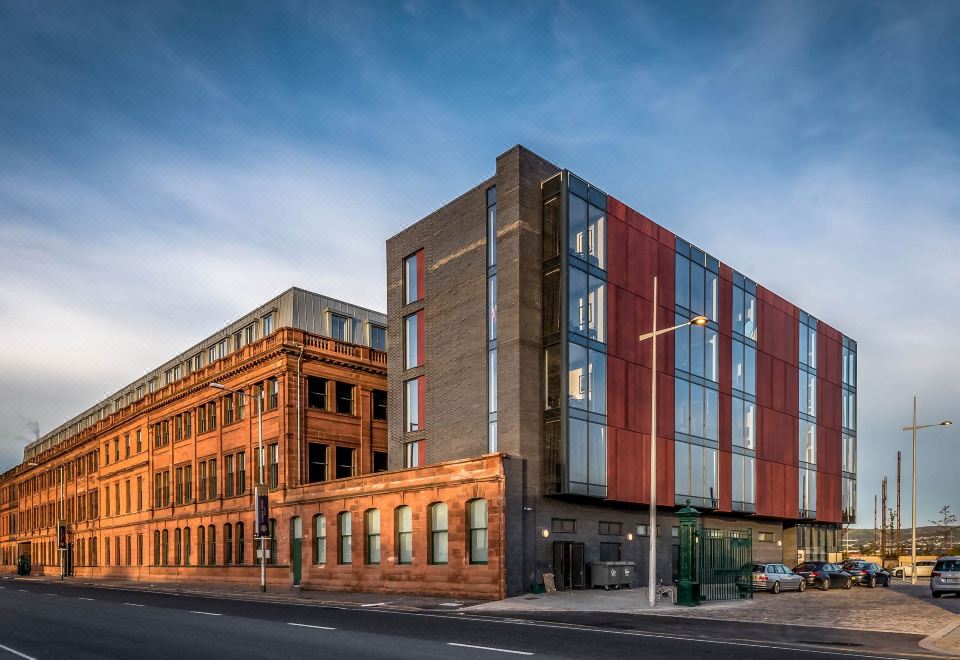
[[0, 0, 960, 526]]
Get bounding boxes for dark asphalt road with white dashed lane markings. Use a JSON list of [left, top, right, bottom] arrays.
[[0, 580, 942, 660]]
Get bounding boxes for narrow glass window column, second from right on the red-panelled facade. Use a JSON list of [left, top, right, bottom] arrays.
[[798, 311, 817, 518]]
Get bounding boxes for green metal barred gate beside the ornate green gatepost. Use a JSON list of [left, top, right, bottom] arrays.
[[694, 527, 753, 600]]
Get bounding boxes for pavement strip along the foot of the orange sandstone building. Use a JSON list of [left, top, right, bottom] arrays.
[[3, 575, 482, 611]]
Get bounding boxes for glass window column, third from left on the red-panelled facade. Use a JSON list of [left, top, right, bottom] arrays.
[[731, 272, 757, 513]]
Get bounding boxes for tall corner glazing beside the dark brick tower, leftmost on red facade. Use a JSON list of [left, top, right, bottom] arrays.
[[542, 172, 607, 497]]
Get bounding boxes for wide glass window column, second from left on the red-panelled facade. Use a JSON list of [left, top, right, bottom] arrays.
[[674, 238, 720, 509]]
